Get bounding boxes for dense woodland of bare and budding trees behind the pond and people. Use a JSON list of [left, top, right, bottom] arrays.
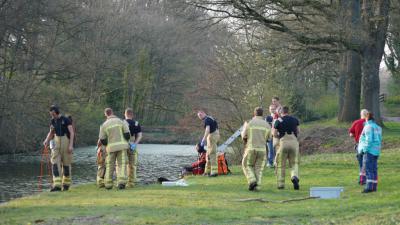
[[0, 0, 400, 153]]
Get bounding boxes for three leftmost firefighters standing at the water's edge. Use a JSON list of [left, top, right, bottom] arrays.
[[43, 106, 142, 192]]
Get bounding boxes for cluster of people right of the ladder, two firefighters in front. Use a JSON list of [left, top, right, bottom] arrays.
[[242, 97, 300, 191]]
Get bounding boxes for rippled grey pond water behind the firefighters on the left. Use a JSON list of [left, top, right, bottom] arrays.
[[0, 144, 197, 202]]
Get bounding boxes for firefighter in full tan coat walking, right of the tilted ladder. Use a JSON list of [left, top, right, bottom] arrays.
[[242, 107, 271, 191]]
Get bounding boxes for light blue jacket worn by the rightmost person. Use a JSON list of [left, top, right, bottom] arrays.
[[358, 120, 382, 156]]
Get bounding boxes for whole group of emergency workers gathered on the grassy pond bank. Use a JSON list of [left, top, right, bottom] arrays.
[[43, 97, 382, 193]]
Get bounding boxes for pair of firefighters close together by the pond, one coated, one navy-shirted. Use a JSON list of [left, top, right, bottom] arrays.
[[97, 108, 142, 189]]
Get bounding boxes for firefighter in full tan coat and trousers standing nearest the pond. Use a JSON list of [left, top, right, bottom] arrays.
[[99, 108, 131, 189]]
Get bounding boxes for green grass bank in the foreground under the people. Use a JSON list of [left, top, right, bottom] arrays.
[[0, 149, 400, 224]]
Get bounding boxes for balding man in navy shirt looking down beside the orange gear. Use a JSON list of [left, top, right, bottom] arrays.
[[197, 110, 219, 177]]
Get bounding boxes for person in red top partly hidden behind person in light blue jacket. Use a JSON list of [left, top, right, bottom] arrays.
[[349, 109, 368, 185]]
